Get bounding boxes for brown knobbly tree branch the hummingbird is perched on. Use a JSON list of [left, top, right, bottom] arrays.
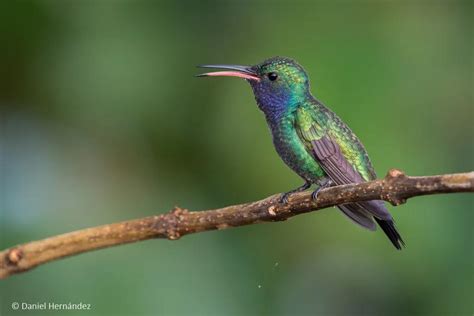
[[0, 169, 474, 279]]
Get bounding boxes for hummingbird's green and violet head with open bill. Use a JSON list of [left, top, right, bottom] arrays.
[[198, 57, 310, 114]]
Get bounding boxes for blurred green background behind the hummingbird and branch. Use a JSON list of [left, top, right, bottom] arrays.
[[0, 1, 474, 315]]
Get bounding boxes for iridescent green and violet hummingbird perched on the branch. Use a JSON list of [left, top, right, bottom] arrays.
[[197, 57, 405, 250]]
